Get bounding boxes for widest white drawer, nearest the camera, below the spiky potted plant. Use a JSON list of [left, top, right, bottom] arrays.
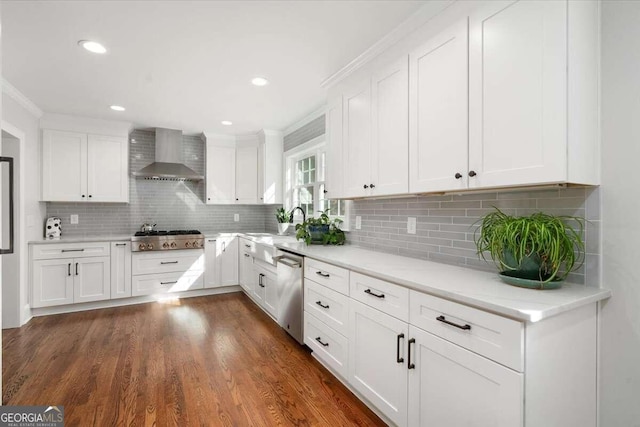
[[410, 290, 524, 372]]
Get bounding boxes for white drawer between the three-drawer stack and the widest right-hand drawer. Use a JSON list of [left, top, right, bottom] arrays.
[[350, 272, 409, 322]]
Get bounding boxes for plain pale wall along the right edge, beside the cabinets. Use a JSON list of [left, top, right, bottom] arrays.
[[599, 1, 640, 427]]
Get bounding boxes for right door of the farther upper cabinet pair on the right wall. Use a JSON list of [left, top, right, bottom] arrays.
[[369, 56, 409, 196]]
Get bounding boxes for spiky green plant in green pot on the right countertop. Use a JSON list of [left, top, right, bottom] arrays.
[[474, 208, 585, 289]]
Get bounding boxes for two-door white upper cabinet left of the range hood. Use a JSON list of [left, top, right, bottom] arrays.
[[42, 130, 129, 202]]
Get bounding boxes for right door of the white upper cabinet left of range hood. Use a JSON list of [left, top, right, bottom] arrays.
[[87, 135, 129, 202]]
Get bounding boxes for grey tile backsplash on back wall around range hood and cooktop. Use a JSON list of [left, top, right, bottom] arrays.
[[42, 130, 278, 236]]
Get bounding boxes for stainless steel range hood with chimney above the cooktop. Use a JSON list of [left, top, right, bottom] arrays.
[[133, 128, 204, 181]]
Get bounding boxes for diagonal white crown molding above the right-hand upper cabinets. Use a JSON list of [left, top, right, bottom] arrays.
[[320, 0, 455, 89]]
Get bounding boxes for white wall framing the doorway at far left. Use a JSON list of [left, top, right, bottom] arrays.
[[2, 93, 46, 323]]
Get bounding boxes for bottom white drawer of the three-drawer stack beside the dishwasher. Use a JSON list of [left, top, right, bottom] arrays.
[[304, 312, 349, 378]]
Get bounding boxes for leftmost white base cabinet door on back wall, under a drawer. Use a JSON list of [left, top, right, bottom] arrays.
[[31, 258, 74, 308]]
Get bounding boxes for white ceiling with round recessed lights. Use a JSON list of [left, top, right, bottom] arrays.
[[1, 1, 425, 134]]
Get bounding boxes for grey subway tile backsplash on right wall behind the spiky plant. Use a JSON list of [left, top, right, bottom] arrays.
[[348, 188, 601, 286]]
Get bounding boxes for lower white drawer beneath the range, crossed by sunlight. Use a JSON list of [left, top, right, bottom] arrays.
[[131, 271, 204, 297]]
